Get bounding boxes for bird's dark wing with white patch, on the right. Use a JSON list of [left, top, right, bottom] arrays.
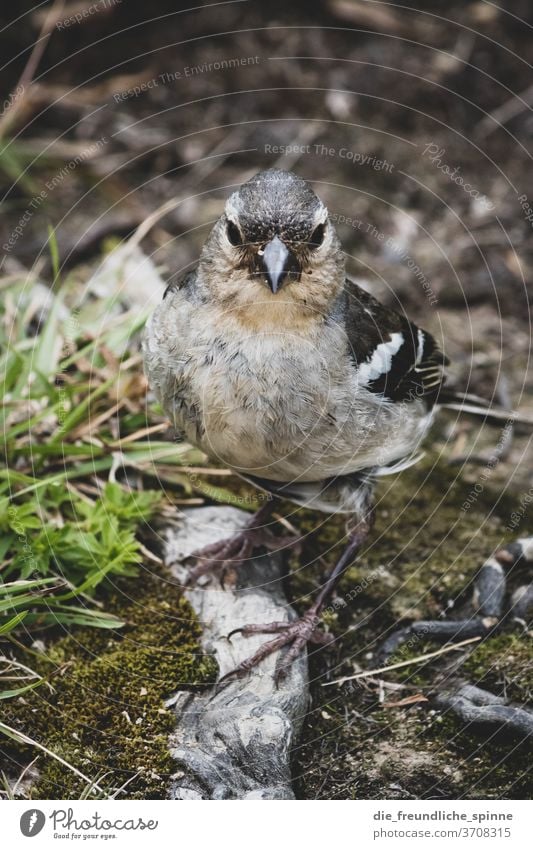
[[345, 279, 448, 408]]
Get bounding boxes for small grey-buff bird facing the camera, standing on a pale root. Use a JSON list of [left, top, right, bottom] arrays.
[[143, 169, 524, 682]]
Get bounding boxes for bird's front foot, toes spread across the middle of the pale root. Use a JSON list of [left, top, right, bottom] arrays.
[[218, 607, 333, 686]]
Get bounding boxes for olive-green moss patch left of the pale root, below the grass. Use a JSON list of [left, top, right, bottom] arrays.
[[7, 574, 216, 799]]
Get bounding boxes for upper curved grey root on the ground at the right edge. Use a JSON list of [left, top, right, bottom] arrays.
[[377, 538, 533, 663]]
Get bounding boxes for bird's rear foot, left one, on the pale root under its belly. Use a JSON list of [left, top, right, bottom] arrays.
[[187, 498, 299, 585]]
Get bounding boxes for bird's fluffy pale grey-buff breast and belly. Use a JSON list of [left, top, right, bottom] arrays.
[[145, 296, 430, 481]]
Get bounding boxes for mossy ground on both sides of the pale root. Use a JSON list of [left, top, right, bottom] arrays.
[[3, 454, 533, 799]]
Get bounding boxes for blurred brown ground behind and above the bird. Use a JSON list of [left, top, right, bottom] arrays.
[[0, 0, 533, 444]]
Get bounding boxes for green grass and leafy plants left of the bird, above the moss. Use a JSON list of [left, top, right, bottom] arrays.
[[0, 256, 216, 697]]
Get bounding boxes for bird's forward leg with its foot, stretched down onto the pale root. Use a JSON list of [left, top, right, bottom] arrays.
[[218, 514, 372, 686]]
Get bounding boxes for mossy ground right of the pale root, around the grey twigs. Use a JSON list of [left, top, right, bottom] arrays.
[[165, 456, 533, 799]]
